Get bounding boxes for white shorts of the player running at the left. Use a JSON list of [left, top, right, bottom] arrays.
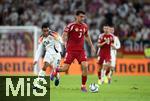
[[43, 52, 61, 68]]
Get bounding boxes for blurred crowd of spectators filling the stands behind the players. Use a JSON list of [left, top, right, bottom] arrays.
[[0, 0, 150, 57]]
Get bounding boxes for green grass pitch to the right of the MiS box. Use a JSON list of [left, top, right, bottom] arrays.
[[50, 75, 150, 101]]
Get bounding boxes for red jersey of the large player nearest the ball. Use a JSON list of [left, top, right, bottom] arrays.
[[64, 22, 88, 51]]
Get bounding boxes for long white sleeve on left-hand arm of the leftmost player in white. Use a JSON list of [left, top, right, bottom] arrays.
[[34, 43, 44, 61]]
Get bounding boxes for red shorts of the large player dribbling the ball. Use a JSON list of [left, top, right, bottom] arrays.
[[64, 50, 87, 64]]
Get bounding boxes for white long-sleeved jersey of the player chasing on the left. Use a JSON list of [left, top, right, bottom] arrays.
[[34, 32, 62, 63]]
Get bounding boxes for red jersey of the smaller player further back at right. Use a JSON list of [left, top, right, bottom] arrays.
[[98, 33, 114, 57]]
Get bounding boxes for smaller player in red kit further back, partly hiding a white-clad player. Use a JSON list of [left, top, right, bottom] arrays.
[[98, 26, 114, 84]]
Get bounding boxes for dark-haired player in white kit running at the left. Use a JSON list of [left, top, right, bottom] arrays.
[[33, 23, 62, 86]]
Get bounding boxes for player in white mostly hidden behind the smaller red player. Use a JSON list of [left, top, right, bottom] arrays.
[[105, 27, 121, 83]]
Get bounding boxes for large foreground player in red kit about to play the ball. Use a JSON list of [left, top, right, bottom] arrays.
[[51, 10, 95, 92]]
